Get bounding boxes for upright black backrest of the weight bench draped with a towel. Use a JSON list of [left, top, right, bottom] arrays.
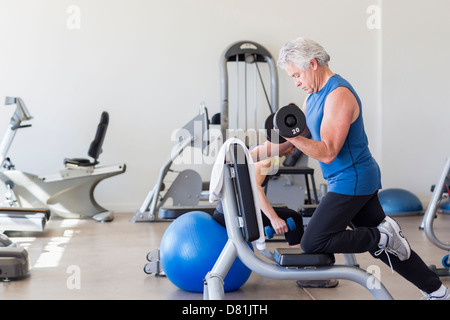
[[229, 144, 260, 242]]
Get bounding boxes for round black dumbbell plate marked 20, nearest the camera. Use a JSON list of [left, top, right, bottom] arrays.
[[273, 105, 306, 138]]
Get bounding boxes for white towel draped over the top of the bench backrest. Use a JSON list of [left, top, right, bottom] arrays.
[[209, 138, 266, 251]]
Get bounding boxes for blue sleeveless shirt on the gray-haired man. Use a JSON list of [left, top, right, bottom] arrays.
[[305, 74, 381, 196]]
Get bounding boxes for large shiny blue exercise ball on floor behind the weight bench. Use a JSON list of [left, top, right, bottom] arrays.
[[160, 211, 251, 292]]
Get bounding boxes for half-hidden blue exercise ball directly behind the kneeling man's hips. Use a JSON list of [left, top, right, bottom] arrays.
[[378, 189, 423, 216]]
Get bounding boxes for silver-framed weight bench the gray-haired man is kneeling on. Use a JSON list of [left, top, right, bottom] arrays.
[[203, 138, 392, 300]]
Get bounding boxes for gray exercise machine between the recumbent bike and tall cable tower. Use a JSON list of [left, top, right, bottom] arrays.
[[131, 103, 215, 222]]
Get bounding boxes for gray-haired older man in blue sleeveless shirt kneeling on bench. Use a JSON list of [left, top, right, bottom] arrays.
[[252, 38, 450, 299]]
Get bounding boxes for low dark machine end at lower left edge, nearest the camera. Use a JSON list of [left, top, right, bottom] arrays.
[[0, 233, 30, 281]]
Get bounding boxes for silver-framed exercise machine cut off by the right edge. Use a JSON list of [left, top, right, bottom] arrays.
[[420, 158, 450, 276]]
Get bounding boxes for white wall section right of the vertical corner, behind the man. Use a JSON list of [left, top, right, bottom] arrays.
[[382, 0, 450, 203]]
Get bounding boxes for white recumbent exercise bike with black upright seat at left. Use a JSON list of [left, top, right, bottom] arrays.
[[0, 97, 126, 231]]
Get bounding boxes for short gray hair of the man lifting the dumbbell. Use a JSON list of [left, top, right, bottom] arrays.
[[277, 38, 330, 70]]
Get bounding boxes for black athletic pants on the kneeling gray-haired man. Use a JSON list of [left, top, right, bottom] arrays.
[[301, 192, 442, 293]]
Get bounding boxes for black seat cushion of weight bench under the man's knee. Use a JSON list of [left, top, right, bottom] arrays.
[[273, 248, 335, 267]]
